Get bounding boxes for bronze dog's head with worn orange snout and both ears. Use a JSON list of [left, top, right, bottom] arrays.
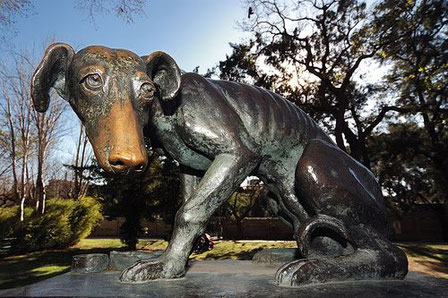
[[31, 43, 181, 174]]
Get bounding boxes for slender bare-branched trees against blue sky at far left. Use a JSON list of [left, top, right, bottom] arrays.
[[0, 51, 66, 221]]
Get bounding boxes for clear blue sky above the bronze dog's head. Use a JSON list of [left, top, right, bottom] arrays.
[[0, 0, 246, 163]]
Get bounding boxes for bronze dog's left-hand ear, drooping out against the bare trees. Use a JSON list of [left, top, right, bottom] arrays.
[[31, 43, 75, 112]]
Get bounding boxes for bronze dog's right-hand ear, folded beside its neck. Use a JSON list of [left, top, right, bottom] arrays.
[[142, 52, 181, 100]]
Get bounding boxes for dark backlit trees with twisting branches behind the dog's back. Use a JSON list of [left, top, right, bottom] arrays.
[[218, 0, 448, 217]]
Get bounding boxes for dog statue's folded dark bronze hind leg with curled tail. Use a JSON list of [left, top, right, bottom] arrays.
[[276, 140, 407, 286]]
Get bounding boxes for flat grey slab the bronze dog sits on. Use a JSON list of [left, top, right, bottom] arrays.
[[0, 260, 448, 298]]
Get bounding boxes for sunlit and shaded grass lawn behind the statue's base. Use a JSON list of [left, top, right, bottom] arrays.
[[0, 239, 448, 289]]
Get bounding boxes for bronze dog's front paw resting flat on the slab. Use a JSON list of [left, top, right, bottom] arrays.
[[120, 260, 173, 283]]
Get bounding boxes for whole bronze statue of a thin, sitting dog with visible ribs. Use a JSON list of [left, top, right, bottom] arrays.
[[31, 43, 407, 285]]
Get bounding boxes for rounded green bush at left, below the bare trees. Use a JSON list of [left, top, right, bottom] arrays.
[[0, 197, 102, 253]]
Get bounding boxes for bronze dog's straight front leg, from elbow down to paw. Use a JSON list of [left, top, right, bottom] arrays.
[[120, 152, 258, 282]]
